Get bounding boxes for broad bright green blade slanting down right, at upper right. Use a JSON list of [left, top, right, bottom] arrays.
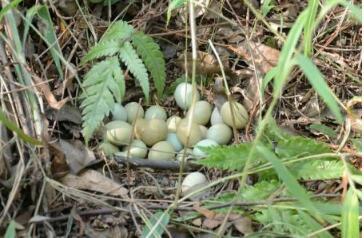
[[296, 55, 344, 123]]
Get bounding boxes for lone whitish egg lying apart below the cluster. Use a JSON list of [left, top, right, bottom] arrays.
[[181, 172, 207, 198]]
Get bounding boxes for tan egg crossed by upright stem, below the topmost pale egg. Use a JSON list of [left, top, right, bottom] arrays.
[[177, 119, 202, 147]]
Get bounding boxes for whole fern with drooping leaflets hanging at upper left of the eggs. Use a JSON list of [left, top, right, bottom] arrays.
[[80, 21, 166, 142]]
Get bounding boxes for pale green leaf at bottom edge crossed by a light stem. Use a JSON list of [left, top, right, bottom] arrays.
[[142, 211, 170, 238]]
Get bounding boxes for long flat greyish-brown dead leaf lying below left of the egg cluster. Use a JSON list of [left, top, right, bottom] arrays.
[[61, 170, 128, 198]]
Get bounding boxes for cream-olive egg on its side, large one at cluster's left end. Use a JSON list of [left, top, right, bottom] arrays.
[[105, 121, 133, 145]]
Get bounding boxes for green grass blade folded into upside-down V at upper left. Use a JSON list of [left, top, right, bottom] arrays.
[[23, 5, 63, 79]]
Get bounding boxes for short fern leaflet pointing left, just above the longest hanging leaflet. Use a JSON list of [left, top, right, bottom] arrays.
[[81, 40, 120, 64]]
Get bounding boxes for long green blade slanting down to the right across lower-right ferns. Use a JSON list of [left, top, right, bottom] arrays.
[[257, 145, 322, 221]]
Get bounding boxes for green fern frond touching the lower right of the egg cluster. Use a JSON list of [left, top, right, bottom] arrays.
[[196, 143, 259, 171]]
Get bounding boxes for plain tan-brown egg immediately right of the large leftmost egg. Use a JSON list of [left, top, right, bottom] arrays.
[[138, 119, 168, 146]]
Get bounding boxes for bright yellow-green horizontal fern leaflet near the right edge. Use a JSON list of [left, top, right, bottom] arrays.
[[290, 160, 344, 180]]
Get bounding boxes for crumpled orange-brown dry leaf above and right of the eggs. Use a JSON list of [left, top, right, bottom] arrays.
[[228, 42, 280, 74]]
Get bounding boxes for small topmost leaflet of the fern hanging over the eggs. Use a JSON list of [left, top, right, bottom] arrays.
[[100, 20, 134, 42]]
